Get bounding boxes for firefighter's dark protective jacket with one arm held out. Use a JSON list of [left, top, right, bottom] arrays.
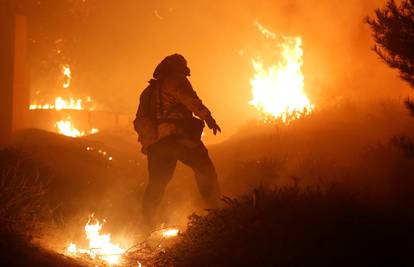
[[134, 75, 212, 153]]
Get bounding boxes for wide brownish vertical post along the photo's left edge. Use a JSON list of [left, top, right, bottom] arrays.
[[0, 1, 30, 145]]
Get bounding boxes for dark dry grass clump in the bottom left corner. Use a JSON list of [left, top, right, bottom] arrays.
[[0, 149, 85, 267]]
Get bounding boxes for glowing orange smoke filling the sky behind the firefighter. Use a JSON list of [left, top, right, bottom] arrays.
[[31, 0, 408, 140]]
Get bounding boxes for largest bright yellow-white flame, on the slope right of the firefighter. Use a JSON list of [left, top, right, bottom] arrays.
[[249, 23, 314, 124]]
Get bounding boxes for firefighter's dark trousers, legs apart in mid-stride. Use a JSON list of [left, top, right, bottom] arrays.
[[143, 136, 220, 225]]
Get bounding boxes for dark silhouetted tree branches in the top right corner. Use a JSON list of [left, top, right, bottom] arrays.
[[367, 0, 414, 116]]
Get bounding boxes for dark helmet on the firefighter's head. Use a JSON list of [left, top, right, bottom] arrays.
[[153, 54, 190, 79]]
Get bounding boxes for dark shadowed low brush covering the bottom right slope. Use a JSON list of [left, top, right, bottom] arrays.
[[159, 187, 414, 266]]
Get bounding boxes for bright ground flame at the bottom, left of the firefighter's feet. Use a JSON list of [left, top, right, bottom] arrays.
[[66, 218, 126, 265]]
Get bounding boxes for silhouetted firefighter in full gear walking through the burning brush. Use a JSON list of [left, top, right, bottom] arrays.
[[134, 54, 221, 226]]
